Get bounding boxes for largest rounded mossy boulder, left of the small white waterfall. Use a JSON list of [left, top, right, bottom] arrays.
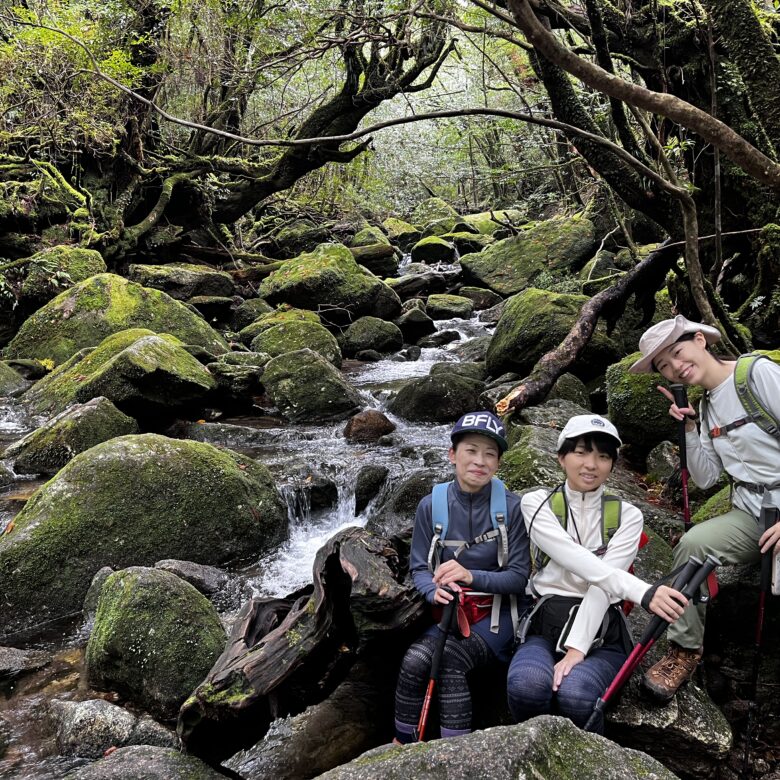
[[0, 436, 288, 631]]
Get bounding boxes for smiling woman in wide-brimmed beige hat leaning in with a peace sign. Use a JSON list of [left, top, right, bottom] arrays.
[[631, 315, 780, 701]]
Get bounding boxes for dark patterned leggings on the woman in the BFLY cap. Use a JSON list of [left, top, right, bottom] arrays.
[[395, 627, 496, 742]]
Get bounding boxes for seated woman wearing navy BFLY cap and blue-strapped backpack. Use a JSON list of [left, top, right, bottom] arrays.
[[395, 411, 529, 743]]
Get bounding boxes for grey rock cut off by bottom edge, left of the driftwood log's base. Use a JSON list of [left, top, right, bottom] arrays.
[[62, 745, 225, 780]]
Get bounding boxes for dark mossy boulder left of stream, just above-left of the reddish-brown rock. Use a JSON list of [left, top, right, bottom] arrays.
[[263, 349, 362, 422]]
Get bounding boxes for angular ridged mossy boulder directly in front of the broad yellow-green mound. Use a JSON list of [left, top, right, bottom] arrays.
[[25, 328, 216, 416]]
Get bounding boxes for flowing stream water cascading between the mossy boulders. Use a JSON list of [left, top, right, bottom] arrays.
[[0, 270, 488, 780]]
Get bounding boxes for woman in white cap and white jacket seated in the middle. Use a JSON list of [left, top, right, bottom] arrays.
[[507, 414, 685, 732]]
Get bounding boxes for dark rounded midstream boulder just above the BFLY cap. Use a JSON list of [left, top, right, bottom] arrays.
[[387, 374, 484, 423]]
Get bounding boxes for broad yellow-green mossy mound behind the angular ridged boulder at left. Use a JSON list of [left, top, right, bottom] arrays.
[[6, 274, 228, 365]]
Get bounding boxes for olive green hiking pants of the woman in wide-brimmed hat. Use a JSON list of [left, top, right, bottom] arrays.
[[668, 502, 762, 650]]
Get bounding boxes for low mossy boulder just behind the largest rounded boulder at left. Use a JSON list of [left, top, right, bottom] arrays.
[[3, 396, 138, 474]]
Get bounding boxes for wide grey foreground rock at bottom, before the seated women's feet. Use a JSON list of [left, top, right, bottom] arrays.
[[319, 715, 676, 780]]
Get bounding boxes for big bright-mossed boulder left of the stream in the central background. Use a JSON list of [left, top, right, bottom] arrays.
[[260, 244, 401, 324]]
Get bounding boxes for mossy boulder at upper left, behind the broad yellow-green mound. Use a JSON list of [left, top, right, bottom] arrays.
[[19, 245, 106, 311]]
